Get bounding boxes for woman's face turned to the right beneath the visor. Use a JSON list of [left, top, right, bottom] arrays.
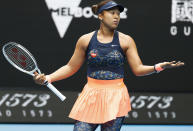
[[99, 8, 120, 29]]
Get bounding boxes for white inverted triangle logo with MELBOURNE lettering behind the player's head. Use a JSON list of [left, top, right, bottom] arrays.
[[45, 0, 127, 38]]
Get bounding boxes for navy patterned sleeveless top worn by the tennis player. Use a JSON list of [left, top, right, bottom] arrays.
[[86, 30, 125, 80]]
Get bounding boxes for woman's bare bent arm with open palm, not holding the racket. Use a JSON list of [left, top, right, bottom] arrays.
[[125, 36, 184, 76]]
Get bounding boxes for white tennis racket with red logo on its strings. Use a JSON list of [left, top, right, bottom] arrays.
[[2, 42, 66, 101]]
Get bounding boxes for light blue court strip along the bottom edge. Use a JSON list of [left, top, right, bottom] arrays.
[[0, 124, 193, 131]]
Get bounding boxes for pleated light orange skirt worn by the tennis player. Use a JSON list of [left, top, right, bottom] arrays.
[[69, 77, 131, 124]]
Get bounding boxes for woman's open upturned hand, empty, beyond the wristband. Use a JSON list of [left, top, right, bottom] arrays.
[[159, 61, 185, 69]]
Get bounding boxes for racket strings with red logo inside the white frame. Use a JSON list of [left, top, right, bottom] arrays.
[[5, 45, 36, 71]]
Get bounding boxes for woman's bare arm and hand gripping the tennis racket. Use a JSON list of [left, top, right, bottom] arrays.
[[34, 35, 89, 84]]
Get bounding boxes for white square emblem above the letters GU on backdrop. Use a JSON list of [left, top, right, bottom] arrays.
[[171, 0, 193, 23]]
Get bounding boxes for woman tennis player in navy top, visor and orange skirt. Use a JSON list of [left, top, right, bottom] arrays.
[[34, 0, 184, 131]]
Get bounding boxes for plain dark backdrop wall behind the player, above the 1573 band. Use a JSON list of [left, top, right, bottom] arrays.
[[0, 0, 193, 92]]
